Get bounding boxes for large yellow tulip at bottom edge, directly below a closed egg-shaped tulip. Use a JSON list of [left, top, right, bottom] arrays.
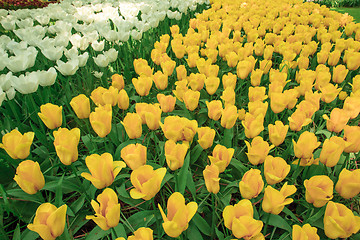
[[223, 199, 264, 240]]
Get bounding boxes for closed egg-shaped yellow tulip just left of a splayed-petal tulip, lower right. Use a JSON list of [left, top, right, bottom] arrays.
[[239, 168, 264, 199]]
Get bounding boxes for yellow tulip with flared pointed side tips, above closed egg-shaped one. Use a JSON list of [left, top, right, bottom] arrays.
[[245, 136, 274, 165]]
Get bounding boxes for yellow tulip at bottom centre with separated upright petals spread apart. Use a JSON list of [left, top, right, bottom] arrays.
[[158, 192, 198, 238]]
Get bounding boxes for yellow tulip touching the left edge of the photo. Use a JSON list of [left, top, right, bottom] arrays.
[[0, 129, 35, 159]]
